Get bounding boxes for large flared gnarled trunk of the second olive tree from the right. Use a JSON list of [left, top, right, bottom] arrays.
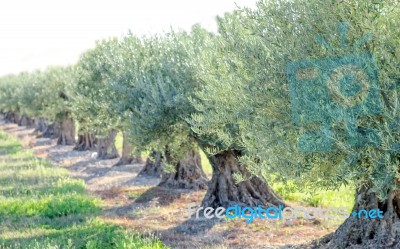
[[202, 150, 286, 208]]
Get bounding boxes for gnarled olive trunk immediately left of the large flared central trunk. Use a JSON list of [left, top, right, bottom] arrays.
[[159, 150, 208, 189]]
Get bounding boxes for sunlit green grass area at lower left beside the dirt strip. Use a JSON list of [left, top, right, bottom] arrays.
[[0, 131, 166, 249]]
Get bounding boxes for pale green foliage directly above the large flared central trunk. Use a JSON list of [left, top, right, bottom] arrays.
[[188, 13, 253, 154]]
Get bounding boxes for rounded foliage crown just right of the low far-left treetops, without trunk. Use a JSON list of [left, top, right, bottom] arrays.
[[71, 39, 121, 133]]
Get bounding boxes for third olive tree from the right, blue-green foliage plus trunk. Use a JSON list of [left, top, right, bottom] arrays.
[[116, 26, 210, 188]]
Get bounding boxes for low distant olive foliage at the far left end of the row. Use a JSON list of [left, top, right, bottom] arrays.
[[0, 67, 74, 120]]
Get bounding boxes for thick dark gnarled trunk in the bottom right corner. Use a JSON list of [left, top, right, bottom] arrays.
[[313, 187, 400, 249]]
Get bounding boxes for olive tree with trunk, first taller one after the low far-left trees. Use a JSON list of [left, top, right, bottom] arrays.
[[73, 38, 119, 159]]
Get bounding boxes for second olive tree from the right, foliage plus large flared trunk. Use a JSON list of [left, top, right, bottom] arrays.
[[187, 12, 285, 207]]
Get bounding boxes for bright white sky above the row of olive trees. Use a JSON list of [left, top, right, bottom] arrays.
[[0, 0, 256, 75]]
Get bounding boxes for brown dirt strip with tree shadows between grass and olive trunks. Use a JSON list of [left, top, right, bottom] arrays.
[[0, 122, 338, 248]]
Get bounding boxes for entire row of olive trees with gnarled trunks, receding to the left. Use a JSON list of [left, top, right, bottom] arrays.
[[0, 0, 400, 247]]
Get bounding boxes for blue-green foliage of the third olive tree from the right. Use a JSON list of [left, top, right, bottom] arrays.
[[120, 26, 216, 158]]
